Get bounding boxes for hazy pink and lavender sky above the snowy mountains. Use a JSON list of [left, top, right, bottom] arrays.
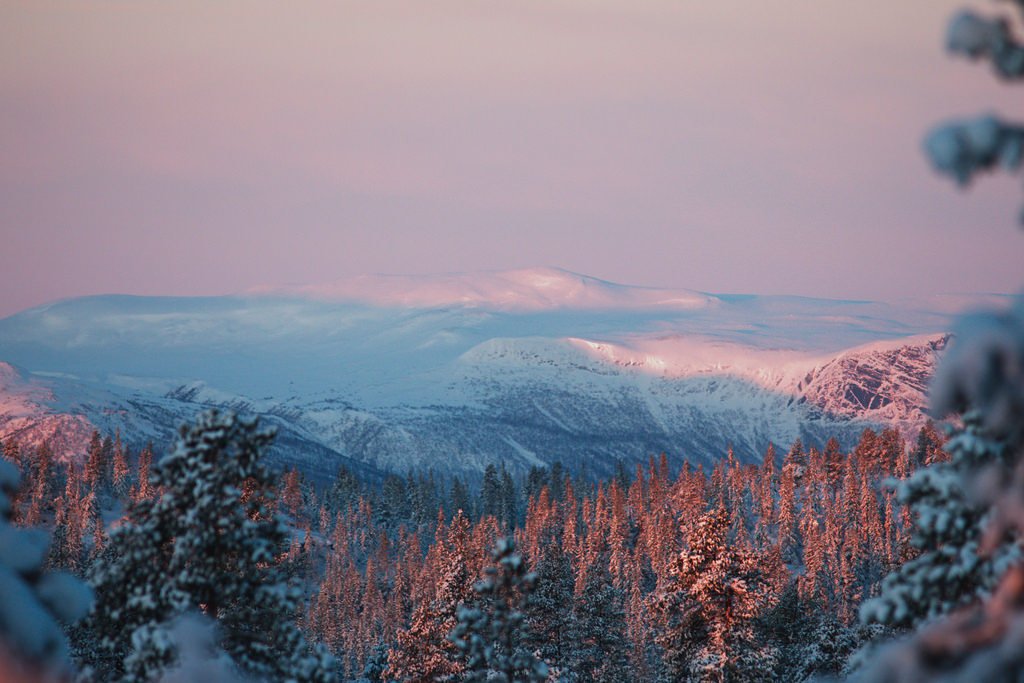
[[0, 0, 1024, 315]]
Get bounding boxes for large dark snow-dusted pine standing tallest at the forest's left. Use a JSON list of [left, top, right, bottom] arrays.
[[87, 411, 330, 681]]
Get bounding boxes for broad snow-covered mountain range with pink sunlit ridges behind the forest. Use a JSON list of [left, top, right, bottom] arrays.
[[0, 268, 974, 476]]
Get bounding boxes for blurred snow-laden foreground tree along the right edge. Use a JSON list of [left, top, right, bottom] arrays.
[[862, 1, 1024, 681]]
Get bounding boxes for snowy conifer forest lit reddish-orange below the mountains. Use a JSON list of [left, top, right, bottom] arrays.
[[3, 412, 949, 682]]
